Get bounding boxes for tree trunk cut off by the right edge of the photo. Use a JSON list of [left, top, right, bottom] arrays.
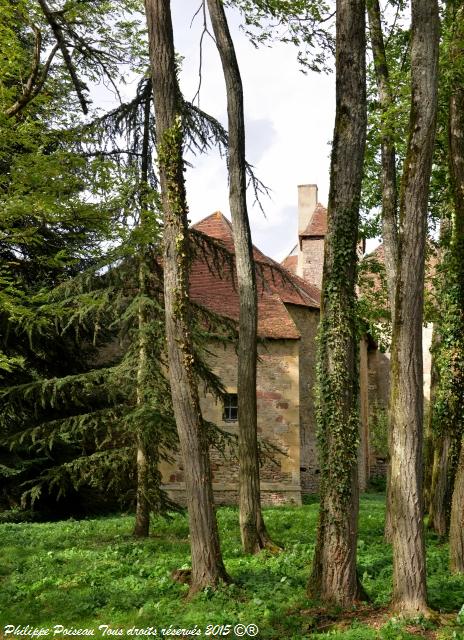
[[449, 0, 464, 572]]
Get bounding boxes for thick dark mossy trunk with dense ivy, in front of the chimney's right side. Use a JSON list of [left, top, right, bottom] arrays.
[[308, 0, 366, 606]]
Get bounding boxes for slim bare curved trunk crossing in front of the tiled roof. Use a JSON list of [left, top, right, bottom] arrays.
[[208, 0, 269, 553]]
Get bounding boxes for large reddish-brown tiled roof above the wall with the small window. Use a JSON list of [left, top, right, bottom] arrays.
[[190, 212, 320, 339]]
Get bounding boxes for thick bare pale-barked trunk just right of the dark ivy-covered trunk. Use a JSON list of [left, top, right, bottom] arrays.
[[390, 0, 439, 614]]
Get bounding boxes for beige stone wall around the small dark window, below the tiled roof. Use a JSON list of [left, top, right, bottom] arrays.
[[161, 340, 301, 504]]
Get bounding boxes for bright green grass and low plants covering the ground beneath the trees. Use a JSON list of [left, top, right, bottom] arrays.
[[0, 495, 464, 640]]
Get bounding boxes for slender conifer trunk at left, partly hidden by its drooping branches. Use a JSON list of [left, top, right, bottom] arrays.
[[134, 85, 153, 538]]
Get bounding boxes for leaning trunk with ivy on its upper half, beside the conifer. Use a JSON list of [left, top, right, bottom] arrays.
[[145, 0, 228, 593]]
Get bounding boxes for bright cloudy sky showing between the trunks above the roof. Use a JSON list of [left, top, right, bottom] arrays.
[[172, 0, 335, 260]]
